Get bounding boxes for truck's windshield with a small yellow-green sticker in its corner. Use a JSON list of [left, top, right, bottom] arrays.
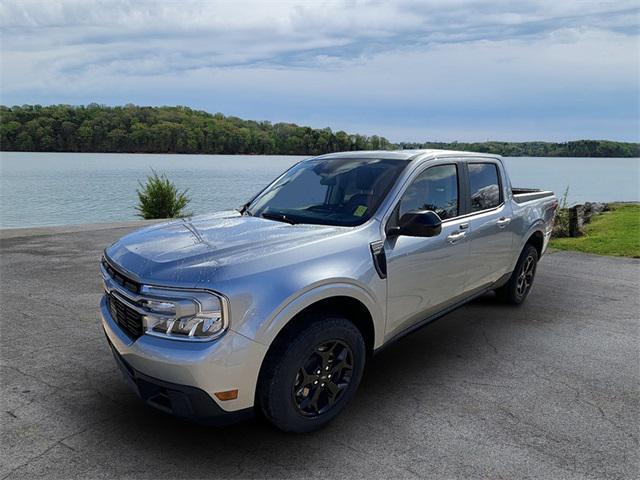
[[246, 158, 408, 226]]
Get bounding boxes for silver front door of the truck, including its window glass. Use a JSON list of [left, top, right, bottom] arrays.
[[385, 163, 469, 338]]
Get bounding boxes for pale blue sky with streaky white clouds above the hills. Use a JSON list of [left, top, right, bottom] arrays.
[[0, 0, 640, 141]]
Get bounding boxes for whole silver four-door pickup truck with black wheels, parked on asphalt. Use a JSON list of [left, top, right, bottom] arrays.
[[100, 150, 558, 432]]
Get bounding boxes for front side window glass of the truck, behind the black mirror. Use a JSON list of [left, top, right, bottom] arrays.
[[399, 165, 458, 220]]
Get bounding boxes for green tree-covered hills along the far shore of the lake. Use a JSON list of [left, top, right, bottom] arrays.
[[0, 104, 640, 157]]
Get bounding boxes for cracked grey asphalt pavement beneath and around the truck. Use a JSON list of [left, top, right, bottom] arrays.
[[0, 227, 640, 479]]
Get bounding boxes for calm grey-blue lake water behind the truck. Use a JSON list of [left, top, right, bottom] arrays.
[[0, 152, 640, 228]]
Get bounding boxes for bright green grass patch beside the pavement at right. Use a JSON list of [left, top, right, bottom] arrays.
[[550, 204, 640, 258]]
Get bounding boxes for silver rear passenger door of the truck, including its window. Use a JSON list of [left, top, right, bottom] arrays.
[[465, 159, 513, 292]]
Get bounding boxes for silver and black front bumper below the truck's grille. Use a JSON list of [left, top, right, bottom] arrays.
[[100, 297, 266, 423]]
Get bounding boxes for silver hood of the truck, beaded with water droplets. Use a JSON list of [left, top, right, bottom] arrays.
[[105, 210, 350, 286]]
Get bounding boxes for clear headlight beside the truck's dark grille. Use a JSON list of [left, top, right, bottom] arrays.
[[140, 285, 229, 341]]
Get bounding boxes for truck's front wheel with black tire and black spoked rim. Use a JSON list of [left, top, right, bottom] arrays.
[[257, 314, 366, 433]]
